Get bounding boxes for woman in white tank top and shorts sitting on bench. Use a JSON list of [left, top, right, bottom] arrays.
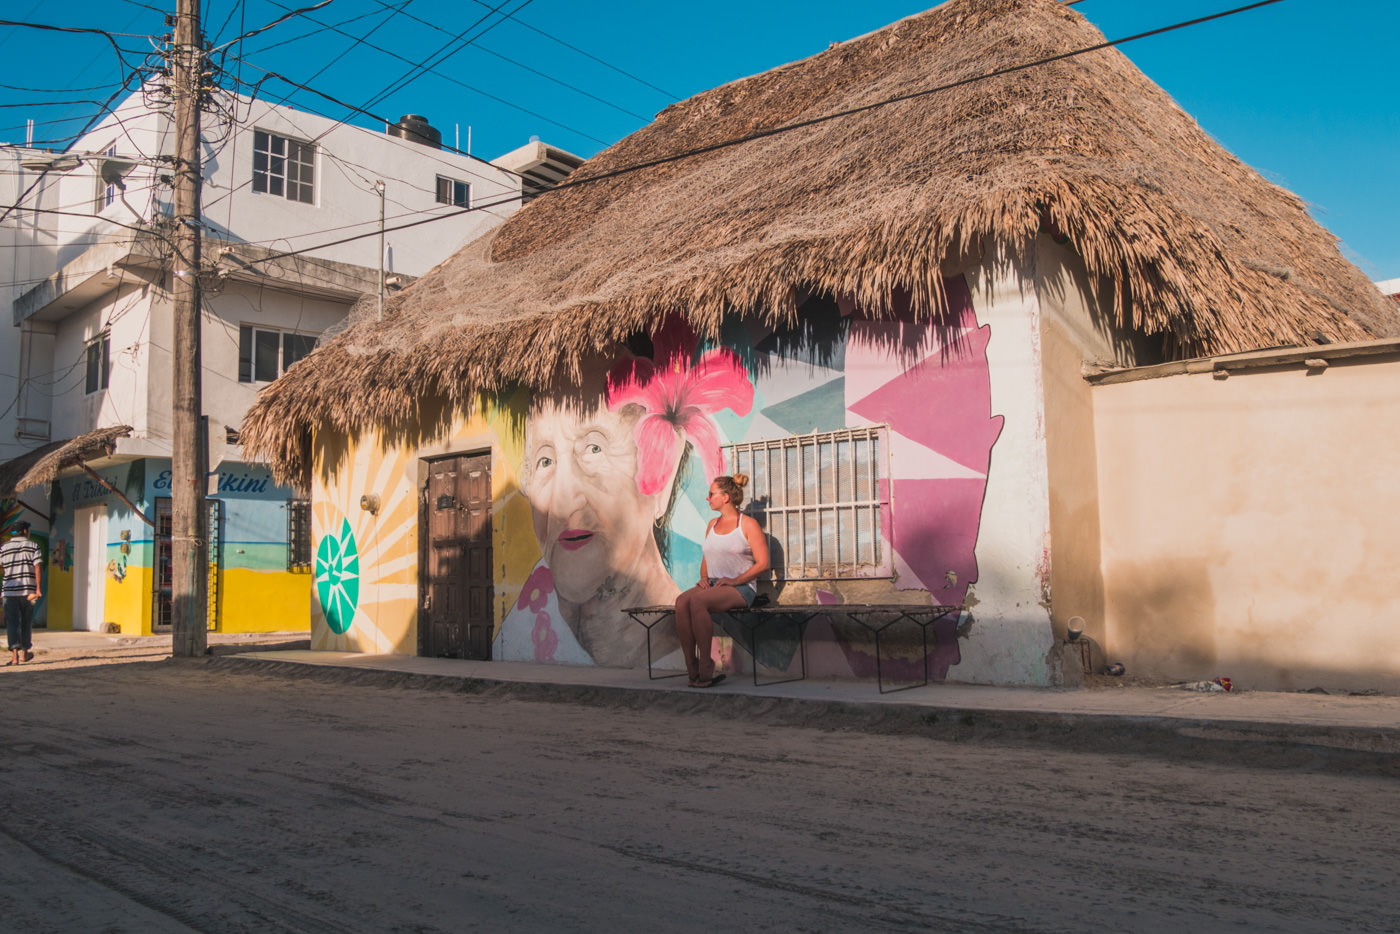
[[676, 473, 769, 688]]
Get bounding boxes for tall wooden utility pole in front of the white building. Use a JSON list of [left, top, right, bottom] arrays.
[[171, 0, 209, 658]]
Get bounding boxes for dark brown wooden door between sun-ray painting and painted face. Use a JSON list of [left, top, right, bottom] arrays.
[[420, 454, 494, 661]]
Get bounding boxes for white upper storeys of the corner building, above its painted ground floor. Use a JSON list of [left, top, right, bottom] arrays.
[[0, 94, 548, 461]]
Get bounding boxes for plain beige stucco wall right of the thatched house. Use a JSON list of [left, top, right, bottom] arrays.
[[1093, 349, 1400, 690]]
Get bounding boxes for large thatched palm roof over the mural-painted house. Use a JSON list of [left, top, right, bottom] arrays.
[[244, 0, 1397, 478]]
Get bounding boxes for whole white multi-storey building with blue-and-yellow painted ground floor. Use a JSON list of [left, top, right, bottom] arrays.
[[0, 88, 577, 633]]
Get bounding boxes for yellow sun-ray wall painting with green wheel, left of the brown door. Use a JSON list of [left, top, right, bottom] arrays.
[[311, 428, 419, 655]]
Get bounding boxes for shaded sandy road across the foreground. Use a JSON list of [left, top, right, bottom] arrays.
[[0, 660, 1400, 934]]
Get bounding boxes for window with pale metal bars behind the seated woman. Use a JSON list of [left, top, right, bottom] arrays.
[[725, 426, 890, 581]]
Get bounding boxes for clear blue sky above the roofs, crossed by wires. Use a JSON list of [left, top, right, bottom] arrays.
[[0, 0, 1400, 279]]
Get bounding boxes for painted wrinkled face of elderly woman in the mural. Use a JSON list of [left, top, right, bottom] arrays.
[[522, 400, 671, 604]]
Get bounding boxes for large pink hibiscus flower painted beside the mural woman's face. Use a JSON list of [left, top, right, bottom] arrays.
[[608, 349, 753, 496]]
